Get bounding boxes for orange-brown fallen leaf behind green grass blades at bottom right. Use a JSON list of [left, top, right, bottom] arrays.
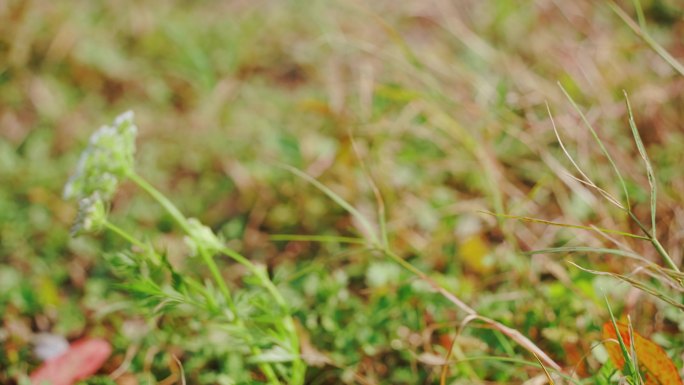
[[603, 321, 684, 385]]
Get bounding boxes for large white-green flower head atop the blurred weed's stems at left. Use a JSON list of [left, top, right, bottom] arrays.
[[64, 111, 138, 232]]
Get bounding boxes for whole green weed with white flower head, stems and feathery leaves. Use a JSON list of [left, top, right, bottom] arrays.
[[64, 111, 306, 385]]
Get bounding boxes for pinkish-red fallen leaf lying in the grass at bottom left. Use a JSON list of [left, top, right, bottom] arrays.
[[30, 338, 112, 385]]
